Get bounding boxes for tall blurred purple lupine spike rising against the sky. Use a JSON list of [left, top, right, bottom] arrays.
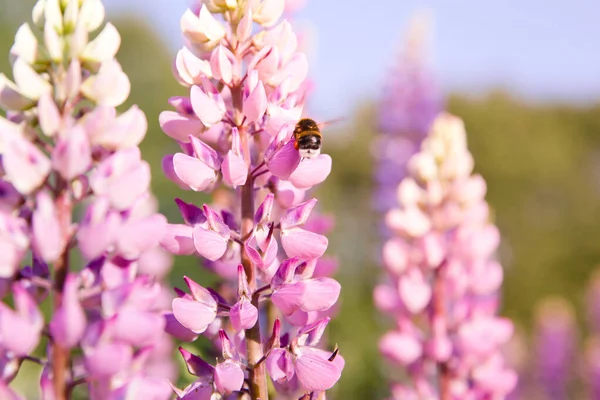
[[373, 14, 444, 216]]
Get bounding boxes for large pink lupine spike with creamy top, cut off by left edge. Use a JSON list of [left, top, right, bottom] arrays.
[[0, 0, 176, 399]]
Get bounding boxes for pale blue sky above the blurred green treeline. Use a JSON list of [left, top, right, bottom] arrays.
[[106, 0, 600, 120]]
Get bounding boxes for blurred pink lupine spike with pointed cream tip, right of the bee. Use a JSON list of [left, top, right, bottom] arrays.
[[374, 113, 517, 400]]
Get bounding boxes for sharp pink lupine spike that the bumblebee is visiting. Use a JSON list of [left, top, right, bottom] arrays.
[[160, 0, 343, 400]]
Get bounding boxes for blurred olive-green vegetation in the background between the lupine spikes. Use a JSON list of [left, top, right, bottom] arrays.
[[0, 0, 600, 399]]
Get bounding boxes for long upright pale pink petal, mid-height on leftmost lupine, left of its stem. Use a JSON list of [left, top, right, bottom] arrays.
[[32, 191, 66, 262]]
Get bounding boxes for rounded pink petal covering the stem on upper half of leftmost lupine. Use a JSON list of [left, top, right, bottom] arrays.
[[52, 125, 92, 180]]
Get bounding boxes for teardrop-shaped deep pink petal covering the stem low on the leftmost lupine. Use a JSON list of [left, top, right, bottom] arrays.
[[50, 274, 87, 349]]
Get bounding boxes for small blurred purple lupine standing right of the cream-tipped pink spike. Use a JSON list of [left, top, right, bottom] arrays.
[[534, 298, 577, 400]]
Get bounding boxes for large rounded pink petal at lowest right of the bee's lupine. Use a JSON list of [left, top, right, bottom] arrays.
[[294, 347, 342, 392]]
